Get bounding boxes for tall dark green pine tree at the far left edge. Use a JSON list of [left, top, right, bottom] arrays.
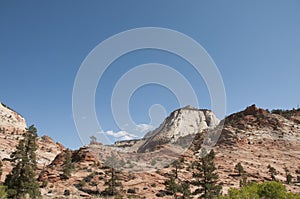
[[4, 125, 41, 198]]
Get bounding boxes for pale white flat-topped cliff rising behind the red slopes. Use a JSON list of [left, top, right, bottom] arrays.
[[138, 106, 220, 152]]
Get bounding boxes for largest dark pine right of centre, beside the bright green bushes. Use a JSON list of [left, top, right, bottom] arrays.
[[193, 149, 222, 199]]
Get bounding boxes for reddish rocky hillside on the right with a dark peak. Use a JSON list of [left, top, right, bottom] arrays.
[[214, 105, 300, 193]]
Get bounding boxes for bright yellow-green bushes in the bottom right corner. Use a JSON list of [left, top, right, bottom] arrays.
[[218, 181, 300, 199]]
